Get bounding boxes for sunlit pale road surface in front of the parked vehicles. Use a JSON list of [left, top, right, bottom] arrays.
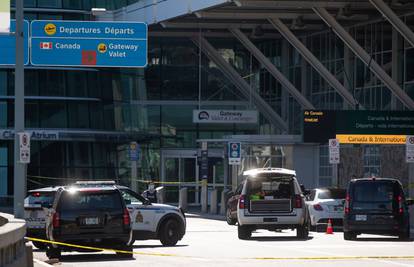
[[34, 218, 414, 267]]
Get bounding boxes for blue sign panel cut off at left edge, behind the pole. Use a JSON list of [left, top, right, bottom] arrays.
[[0, 20, 29, 66]]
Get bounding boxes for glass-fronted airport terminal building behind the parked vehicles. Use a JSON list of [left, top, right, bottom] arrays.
[[0, 0, 414, 206]]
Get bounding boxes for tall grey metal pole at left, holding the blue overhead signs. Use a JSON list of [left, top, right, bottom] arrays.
[[13, 0, 26, 218]]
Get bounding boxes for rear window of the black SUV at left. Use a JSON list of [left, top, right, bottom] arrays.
[[59, 191, 122, 211]]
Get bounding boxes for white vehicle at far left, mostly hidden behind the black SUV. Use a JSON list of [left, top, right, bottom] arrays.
[[24, 186, 60, 249]]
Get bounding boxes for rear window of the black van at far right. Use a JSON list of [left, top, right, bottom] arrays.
[[352, 181, 398, 210]]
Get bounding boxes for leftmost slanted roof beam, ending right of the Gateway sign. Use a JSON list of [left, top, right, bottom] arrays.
[[191, 36, 288, 132]]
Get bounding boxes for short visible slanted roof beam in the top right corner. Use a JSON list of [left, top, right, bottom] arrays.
[[369, 0, 414, 47]]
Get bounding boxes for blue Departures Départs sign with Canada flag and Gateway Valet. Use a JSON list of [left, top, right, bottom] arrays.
[[31, 20, 147, 67]]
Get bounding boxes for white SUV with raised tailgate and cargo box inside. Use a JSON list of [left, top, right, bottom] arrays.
[[237, 168, 309, 239]]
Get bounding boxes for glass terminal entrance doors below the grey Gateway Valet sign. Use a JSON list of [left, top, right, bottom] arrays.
[[161, 150, 227, 206]]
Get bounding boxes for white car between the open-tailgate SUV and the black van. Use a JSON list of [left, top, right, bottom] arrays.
[[306, 188, 346, 232]]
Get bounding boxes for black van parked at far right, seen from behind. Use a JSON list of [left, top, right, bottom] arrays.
[[344, 177, 413, 240]]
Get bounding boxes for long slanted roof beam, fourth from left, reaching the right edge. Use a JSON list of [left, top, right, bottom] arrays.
[[313, 7, 414, 110]]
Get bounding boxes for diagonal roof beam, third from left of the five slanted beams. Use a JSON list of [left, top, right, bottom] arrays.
[[269, 18, 358, 108]]
